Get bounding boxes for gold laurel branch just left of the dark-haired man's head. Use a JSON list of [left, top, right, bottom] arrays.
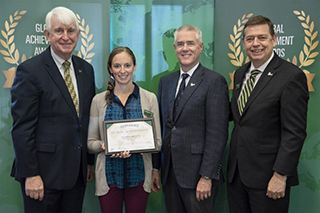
[[228, 13, 253, 67]]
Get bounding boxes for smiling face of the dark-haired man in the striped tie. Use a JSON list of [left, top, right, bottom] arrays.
[[242, 24, 277, 68]]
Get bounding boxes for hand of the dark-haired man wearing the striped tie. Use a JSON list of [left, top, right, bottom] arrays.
[[266, 172, 287, 200]]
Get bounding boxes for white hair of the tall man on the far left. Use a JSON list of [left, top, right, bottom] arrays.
[[45, 7, 79, 32]]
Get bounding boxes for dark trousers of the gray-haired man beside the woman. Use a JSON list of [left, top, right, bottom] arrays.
[[163, 167, 218, 213]]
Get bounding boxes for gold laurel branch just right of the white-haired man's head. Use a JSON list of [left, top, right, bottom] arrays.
[[76, 14, 95, 63]]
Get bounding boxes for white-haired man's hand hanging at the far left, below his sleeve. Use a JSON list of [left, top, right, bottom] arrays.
[[25, 175, 44, 201]]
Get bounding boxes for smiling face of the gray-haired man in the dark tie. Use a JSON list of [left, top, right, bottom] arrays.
[[174, 30, 203, 72]]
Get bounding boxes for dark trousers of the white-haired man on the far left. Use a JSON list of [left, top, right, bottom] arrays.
[[21, 175, 86, 213]]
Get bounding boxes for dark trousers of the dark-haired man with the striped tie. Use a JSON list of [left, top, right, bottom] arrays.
[[227, 166, 290, 213]]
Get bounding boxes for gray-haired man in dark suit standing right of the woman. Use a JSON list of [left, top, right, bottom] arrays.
[[153, 25, 229, 212]]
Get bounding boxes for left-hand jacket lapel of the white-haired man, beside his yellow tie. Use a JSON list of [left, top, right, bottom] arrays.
[[45, 47, 78, 117]]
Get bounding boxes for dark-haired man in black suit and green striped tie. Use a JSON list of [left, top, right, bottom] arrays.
[[227, 16, 309, 212]]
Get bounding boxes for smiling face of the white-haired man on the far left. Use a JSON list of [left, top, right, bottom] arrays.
[[45, 16, 80, 60]]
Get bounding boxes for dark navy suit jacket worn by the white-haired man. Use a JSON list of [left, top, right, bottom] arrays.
[[11, 47, 95, 190]]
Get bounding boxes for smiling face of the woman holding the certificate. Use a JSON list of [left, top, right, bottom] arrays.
[[109, 52, 136, 85]]
